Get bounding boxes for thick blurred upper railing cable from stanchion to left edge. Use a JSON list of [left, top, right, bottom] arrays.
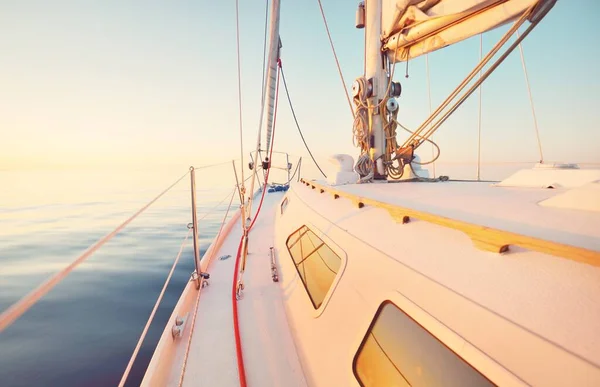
[[0, 172, 189, 332]]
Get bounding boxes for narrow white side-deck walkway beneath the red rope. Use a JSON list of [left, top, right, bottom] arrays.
[[182, 192, 306, 386]]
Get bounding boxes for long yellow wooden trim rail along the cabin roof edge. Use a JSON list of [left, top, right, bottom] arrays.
[[301, 179, 600, 267]]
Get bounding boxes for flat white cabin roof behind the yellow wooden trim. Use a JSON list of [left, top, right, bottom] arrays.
[[328, 181, 600, 251]]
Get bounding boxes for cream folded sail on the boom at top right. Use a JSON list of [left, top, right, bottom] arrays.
[[382, 0, 556, 62]]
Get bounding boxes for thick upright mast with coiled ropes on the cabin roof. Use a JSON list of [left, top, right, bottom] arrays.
[[365, 0, 388, 179]]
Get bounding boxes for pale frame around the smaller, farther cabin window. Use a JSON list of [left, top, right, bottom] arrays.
[[285, 223, 347, 312]]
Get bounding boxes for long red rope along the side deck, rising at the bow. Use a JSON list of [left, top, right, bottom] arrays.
[[231, 60, 281, 387]]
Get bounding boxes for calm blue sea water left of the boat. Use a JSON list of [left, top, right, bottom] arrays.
[[0, 168, 239, 387]]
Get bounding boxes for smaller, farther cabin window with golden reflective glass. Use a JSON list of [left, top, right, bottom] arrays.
[[286, 226, 342, 309]]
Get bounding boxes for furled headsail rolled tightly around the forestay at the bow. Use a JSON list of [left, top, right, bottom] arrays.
[[265, 0, 281, 158]]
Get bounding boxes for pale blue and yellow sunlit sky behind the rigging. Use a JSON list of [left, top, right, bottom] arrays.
[[0, 0, 600, 173]]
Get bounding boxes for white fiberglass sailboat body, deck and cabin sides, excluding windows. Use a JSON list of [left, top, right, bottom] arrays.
[[144, 175, 600, 386]]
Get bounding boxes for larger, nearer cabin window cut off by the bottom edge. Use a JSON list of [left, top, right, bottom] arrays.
[[353, 301, 494, 387]]
